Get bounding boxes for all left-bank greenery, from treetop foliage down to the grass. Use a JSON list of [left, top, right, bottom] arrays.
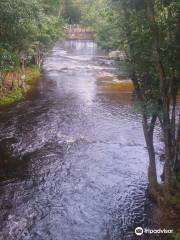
[[0, 0, 65, 105]]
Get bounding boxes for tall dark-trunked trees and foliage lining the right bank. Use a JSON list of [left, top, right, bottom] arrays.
[[87, 0, 180, 201]]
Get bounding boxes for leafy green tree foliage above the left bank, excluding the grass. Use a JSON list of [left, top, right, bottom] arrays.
[[0, 0, 64, 72]]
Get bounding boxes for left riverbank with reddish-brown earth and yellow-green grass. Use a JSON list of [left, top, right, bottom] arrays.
[[0, 66, 41, 108]]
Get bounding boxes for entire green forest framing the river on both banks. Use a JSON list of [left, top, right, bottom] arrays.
[[0, 0, 180, 239]]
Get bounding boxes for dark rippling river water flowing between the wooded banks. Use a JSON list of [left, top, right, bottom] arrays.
[[0, 41, 155, 240]]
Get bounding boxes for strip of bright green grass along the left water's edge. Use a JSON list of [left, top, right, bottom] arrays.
[[0, 66, 41, 107]]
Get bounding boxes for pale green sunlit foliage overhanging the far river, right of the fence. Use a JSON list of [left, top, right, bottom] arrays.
[[81, 0, 121, 50]]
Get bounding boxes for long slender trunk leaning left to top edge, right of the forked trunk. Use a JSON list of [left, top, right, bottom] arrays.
[[146, 0, 172, 198]]
